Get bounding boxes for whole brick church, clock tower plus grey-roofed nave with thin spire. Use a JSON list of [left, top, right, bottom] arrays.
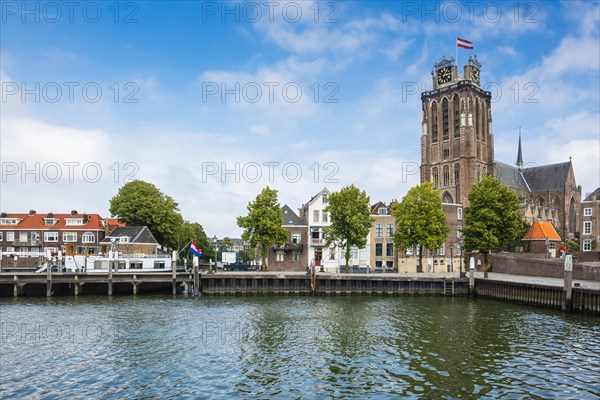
[[420, 56, 581, 245]]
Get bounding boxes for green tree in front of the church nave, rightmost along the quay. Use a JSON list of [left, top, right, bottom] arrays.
[[463, 176, 524, 264]]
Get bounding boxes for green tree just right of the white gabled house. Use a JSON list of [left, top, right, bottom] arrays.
[[325, 185, 373, 271]]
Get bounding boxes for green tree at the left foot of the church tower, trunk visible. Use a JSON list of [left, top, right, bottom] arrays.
[[392, 182, 450, 272]]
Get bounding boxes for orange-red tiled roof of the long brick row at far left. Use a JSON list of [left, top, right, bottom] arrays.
[[0, 213, 106, 231]]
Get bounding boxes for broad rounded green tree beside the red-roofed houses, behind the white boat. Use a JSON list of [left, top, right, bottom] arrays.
[[109, 180, 183, 248]]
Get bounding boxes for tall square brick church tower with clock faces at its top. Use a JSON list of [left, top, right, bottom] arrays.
[[420, 56, 496, 206]]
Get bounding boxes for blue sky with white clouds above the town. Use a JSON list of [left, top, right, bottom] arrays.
[[0, 0, 600, 237]]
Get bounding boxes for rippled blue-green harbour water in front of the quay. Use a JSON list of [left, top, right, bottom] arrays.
[[0, 295, 600, 399]]
